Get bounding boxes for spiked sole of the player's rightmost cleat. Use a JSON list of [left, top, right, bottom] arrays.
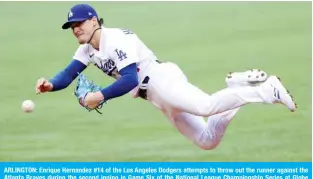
[[270, 76, 298, 112]]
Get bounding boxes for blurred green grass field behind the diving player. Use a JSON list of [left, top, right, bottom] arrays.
[[0, 2, 312, 161]]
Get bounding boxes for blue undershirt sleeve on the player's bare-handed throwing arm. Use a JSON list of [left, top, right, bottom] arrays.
[[49, 59, 87, 91]]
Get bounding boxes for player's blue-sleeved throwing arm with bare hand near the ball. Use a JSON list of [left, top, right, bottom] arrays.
[[35, 60, 87, 94]]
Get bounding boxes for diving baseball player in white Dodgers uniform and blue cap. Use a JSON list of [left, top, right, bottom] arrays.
[[35, 4, 296, 150]]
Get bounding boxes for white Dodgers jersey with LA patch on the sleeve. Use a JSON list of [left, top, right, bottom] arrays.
[[73, 27, 157, 95]]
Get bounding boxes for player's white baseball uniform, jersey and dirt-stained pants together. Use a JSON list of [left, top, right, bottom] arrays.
[[74, 27, 272, 149]]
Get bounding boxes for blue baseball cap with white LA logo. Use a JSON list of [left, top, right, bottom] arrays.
[[62, 4, 98, 29]]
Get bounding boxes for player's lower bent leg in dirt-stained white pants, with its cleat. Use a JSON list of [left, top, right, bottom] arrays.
[[150, 67, 292, 150]]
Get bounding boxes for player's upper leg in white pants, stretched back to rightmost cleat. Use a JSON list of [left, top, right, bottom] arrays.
[[148, 63, 296, 116]]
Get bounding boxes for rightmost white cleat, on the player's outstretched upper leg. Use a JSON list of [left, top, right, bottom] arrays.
[[263, 76, 297, 112]]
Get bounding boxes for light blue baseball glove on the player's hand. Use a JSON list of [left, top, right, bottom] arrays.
[[74, 74, 105, 114]]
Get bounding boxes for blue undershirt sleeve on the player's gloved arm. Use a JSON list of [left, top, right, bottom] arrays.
[[101, 63, 138, 101]]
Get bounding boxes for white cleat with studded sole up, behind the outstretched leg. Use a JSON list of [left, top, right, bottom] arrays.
[[225, 69, 268, 87]]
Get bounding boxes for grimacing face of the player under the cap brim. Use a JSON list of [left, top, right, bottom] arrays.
[[71, 19, 95, 44]]
